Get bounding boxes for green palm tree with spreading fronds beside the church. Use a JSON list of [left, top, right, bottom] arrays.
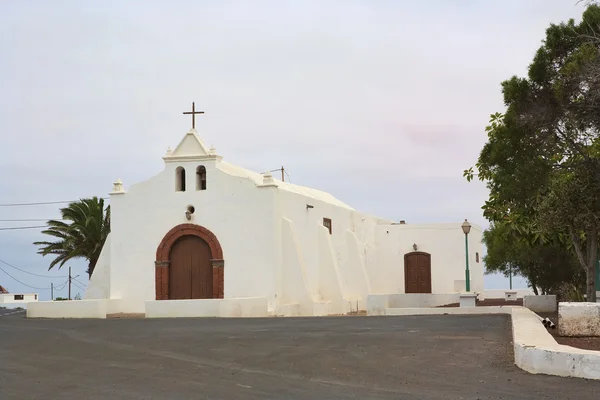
[[33, 197, 110, 278]]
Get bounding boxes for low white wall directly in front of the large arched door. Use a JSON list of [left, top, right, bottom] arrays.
[[146, 297, 268, 318]]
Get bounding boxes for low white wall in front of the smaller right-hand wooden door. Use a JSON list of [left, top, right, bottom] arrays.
[[367, 293, 460, 315]]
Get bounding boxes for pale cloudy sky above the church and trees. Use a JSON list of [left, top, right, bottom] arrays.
[[0, 0, 584, 299]]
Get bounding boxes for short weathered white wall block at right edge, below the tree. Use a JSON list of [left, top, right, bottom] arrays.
[[558, 302, 600, 336]]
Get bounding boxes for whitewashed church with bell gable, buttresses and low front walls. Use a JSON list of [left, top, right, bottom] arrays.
[[29, 107, 483, 317]]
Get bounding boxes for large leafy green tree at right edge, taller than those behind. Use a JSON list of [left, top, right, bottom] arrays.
[[465, 4, 600, 301]]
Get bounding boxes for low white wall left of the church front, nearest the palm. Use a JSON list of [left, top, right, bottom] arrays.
[[27, 300, 106, 318]]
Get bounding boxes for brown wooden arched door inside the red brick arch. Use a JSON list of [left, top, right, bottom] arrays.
[[169, 235, 213, 300]]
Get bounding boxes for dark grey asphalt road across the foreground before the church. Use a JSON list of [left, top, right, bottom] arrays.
[[0, 315, 600, 400]]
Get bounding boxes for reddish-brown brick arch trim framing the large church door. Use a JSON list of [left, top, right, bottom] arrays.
[[154, 224, 225, 300]]
